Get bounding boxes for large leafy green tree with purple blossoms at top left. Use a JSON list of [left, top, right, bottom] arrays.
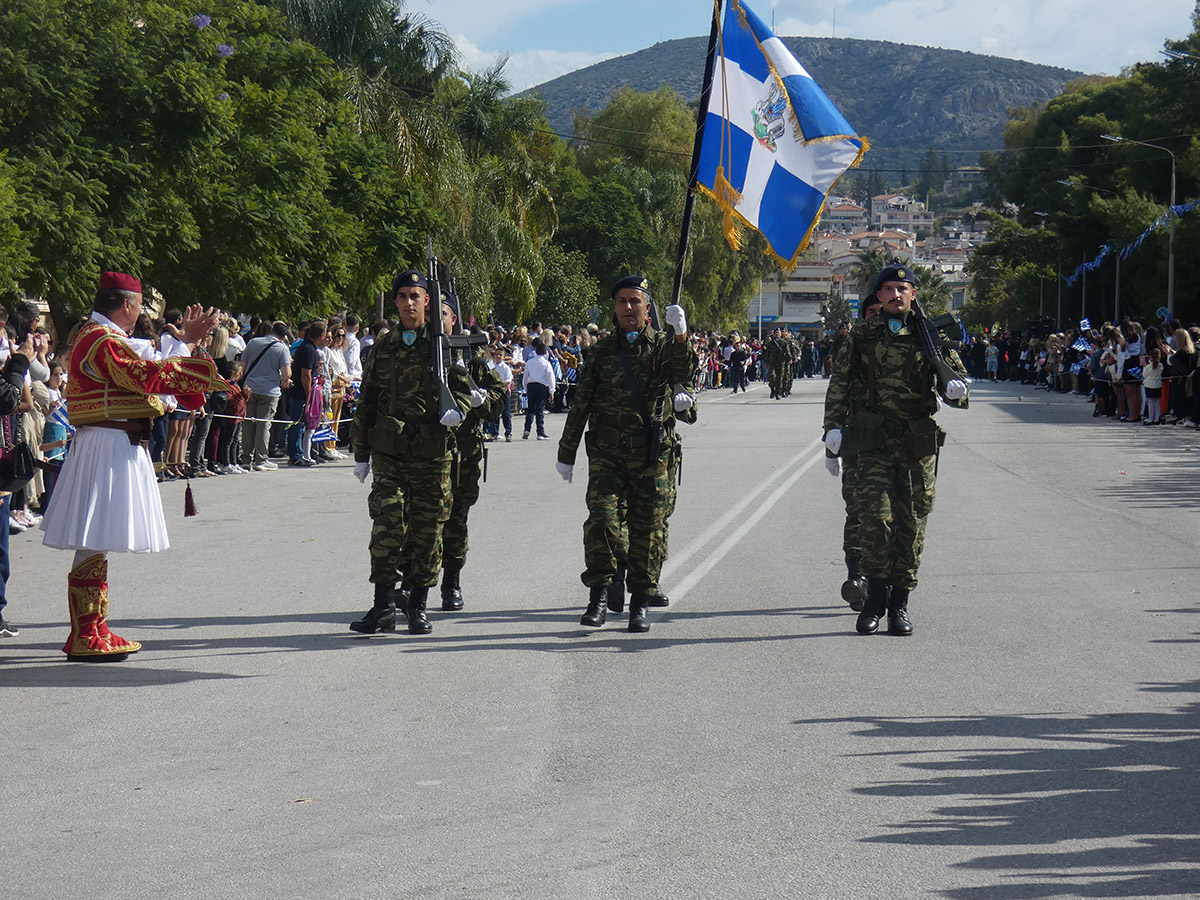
[[0, 0, 431, 326]]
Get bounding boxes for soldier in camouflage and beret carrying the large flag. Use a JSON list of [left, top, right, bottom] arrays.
[[557, 276, 697, 632]]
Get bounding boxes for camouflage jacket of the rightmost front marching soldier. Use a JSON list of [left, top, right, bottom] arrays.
[[824, 314, 966, 432]]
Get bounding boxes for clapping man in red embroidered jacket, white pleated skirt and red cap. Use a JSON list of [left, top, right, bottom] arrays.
[[42, 272, 226, 661]]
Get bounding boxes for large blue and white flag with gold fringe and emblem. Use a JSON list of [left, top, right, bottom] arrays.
[[697, 0, 869, 270]]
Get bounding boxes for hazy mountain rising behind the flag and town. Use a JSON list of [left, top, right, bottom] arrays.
[[526, 37, 1084, 173]]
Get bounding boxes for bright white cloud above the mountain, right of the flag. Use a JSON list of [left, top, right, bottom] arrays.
[[776, 0, 1195, 74]]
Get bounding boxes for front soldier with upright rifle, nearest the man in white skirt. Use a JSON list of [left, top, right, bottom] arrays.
[[350, 269, 472, 635]]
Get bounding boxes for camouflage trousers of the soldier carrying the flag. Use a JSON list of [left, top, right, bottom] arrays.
[[581, 451, 673, 594]]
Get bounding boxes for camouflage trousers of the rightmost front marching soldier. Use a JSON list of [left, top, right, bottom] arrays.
[[854, 442, 937, 590]]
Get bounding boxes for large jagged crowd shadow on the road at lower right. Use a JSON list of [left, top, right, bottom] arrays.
[[796, 682, 1200, 900]]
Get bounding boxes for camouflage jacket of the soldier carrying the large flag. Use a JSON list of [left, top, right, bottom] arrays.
[[558, 325, 698, 466]]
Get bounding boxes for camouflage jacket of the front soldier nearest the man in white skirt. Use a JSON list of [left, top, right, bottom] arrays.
[[350, 324, 470, 462]]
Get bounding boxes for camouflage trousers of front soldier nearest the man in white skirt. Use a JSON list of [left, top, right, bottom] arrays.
[[367, 454, 450, 587]]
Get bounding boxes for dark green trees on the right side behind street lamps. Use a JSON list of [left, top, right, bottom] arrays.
[[976, 13, 1200, 320]]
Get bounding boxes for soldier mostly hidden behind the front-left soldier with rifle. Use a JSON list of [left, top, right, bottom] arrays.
[[442, 295, 509, 612]]
